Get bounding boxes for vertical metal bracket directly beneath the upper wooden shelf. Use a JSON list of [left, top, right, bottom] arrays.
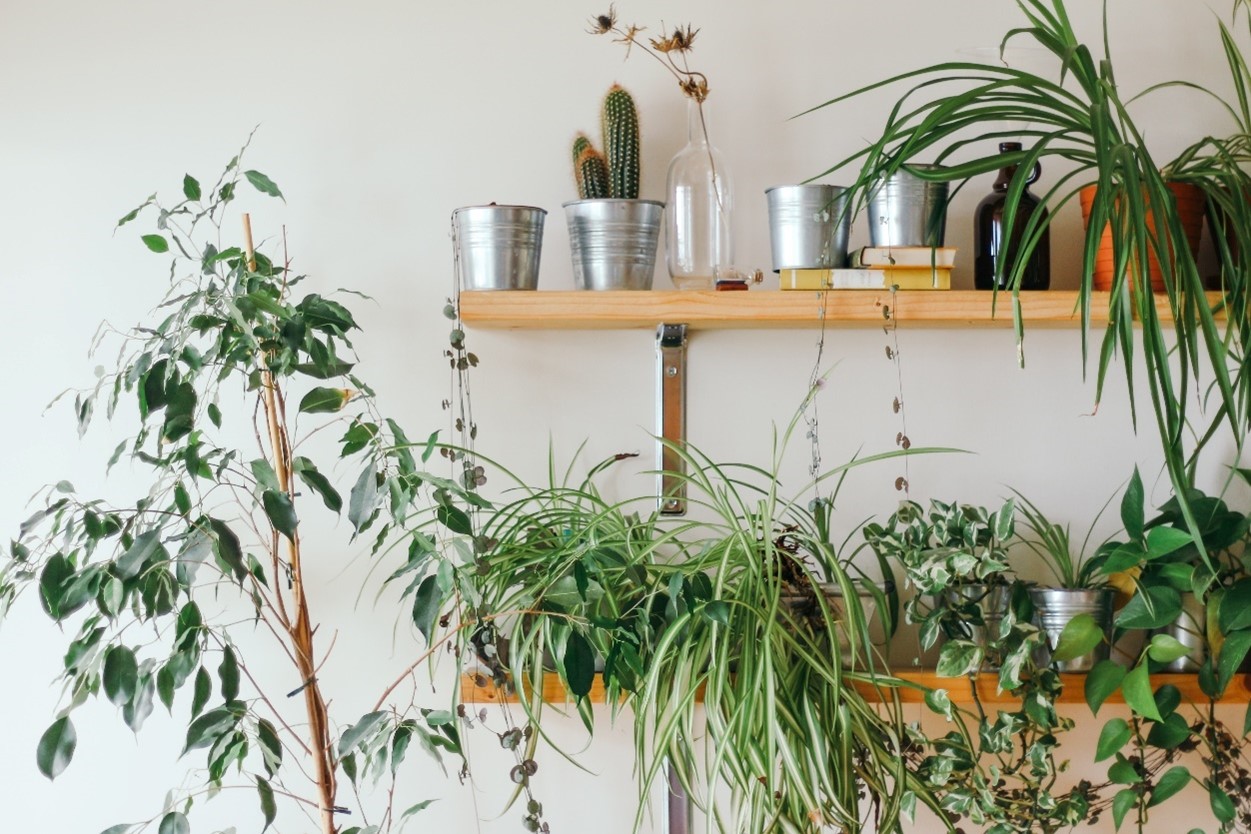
[[656, 324, 687, 515]]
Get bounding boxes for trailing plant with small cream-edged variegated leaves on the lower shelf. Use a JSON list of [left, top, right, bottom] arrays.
[[864, 500, 1098, 834]]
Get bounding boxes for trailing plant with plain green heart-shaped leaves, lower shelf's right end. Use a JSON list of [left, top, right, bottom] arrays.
[[1075, 470, 1251, 831]]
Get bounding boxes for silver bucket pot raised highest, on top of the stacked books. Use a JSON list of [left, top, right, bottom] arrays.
[[868, 165, 947, 246]]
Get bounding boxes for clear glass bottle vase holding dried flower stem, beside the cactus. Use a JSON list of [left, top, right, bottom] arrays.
[[664, 99, 736, 290]]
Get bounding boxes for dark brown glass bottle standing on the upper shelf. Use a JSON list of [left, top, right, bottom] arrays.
[[973, 141, 1051, 290]]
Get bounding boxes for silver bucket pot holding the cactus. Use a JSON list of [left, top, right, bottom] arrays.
[[564, 200, 664, 290]]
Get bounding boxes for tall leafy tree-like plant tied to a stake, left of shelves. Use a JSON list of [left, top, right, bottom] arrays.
[[0, 150, 482, 834]]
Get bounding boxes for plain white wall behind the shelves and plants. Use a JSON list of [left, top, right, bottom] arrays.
[[0, 0, 1245, 834]]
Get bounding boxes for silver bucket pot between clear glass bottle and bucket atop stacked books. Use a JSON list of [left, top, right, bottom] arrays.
[[764, 185, 851, 273]]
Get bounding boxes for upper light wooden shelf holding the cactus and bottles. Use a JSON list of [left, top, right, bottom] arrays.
[[460, 290, 1218, 330]]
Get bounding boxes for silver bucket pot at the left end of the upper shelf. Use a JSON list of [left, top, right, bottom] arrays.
[[452, 204, 547, 290]]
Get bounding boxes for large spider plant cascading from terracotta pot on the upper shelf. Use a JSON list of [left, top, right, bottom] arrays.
[[814, 0, 1251, 565]]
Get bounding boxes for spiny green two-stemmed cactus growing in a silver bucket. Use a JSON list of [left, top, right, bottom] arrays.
[[573, 84, 639, 200]]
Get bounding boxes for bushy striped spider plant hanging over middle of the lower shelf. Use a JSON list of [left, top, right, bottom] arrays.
[[633, 407, 938, 833]]
